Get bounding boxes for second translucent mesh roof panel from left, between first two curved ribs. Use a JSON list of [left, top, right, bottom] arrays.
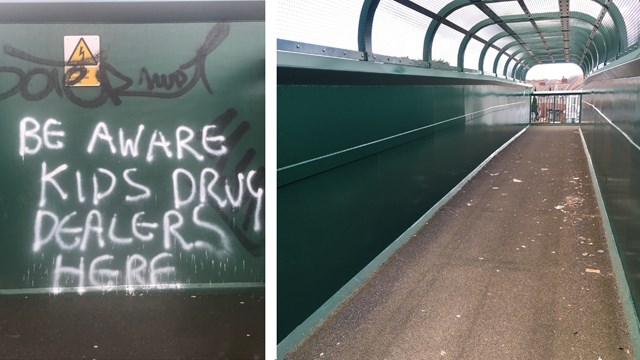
[[371, 0, 431, 60]]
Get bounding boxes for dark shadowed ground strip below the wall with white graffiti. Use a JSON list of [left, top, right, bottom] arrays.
[[0, 291, 265, 359]]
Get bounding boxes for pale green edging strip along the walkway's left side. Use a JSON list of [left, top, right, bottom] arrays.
[[278, 125, 529, 359]]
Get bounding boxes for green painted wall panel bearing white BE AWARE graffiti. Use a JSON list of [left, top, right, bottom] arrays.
[[0, 22, 265, 293]]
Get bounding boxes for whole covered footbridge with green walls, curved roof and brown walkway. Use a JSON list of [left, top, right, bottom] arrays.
[[276, 0, 640, 360]]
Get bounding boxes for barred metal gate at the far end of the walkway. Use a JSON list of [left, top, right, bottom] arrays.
[[529, 91, 585, 125]]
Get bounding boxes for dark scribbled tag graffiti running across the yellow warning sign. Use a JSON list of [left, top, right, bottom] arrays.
[[0, 23, 230, 108]]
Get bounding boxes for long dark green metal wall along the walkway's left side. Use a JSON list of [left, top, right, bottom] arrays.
[[277, 55, 529, 341]]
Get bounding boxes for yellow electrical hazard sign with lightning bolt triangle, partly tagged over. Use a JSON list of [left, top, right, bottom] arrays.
[[64, 35, 100, 86]]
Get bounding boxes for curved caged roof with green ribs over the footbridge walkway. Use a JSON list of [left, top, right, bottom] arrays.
[[277, 0, 640, 80]]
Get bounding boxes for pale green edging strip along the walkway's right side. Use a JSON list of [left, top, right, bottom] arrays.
[[580, 128, 640, 359]]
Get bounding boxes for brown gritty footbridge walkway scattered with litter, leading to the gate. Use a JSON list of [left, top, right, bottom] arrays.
[[287, 127, 633, 360]]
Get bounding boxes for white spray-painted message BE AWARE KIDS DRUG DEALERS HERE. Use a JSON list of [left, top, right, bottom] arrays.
[[19, 117, 264, 292]]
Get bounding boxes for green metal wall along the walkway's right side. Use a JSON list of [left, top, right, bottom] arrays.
[[582, 55, 640, 326]]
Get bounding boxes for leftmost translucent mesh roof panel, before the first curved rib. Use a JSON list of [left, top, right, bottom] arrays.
[[276, 0, 364, 50]]
